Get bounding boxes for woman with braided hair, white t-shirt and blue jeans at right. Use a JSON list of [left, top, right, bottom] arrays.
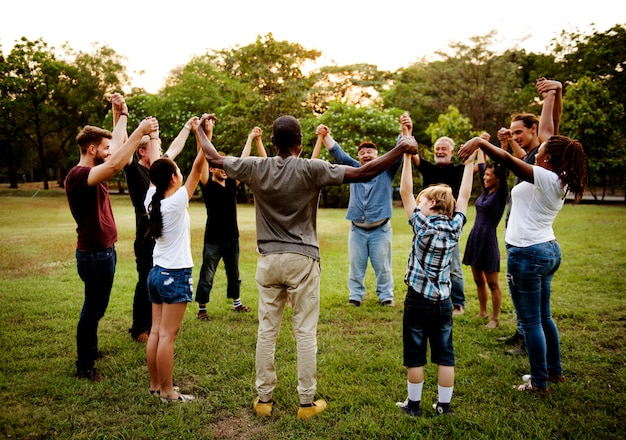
[[459, 136, 587, 392]]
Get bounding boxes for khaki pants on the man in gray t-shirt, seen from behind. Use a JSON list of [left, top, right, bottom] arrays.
[[256, 253, 320, 404]]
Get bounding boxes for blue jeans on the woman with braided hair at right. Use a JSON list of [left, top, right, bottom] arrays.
[[506, 240, 562, 388]]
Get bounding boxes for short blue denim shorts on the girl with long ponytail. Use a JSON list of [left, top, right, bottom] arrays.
[[148, 266, 193, 304]]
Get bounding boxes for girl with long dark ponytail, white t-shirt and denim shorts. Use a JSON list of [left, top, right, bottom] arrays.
[[144, 141, 206, 402]]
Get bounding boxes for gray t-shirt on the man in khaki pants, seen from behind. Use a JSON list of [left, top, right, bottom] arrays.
[[224, 156, 346, 260]]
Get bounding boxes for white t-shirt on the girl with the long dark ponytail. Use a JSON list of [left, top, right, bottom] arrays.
[[144, 186, 193, 269]]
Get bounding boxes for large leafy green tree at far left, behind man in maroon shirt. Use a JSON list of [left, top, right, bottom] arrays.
[[0, 38, 123, 189]]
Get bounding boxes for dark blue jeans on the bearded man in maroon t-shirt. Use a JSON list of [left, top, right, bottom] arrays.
[[76, 246, 117, 373]]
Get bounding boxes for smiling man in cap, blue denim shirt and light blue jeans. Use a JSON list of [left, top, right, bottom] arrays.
[[316, 125, 401, 307]]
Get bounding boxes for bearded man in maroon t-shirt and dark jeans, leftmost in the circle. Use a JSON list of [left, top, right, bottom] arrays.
[[65, 93, 159, 382]]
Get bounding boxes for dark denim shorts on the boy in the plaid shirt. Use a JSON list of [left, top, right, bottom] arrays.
[[402, 287, 454, 367]]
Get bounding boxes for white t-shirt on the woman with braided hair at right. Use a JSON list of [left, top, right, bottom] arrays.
[[504, 166, 565, 247]]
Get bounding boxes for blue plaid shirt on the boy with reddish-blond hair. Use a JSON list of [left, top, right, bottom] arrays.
[[404, 208, 466, 301]]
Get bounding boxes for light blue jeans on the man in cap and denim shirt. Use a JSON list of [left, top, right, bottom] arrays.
[[348, 222, 394, 302]]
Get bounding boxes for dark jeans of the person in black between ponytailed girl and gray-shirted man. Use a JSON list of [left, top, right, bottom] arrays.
[[196, 240, 241, 304]]
